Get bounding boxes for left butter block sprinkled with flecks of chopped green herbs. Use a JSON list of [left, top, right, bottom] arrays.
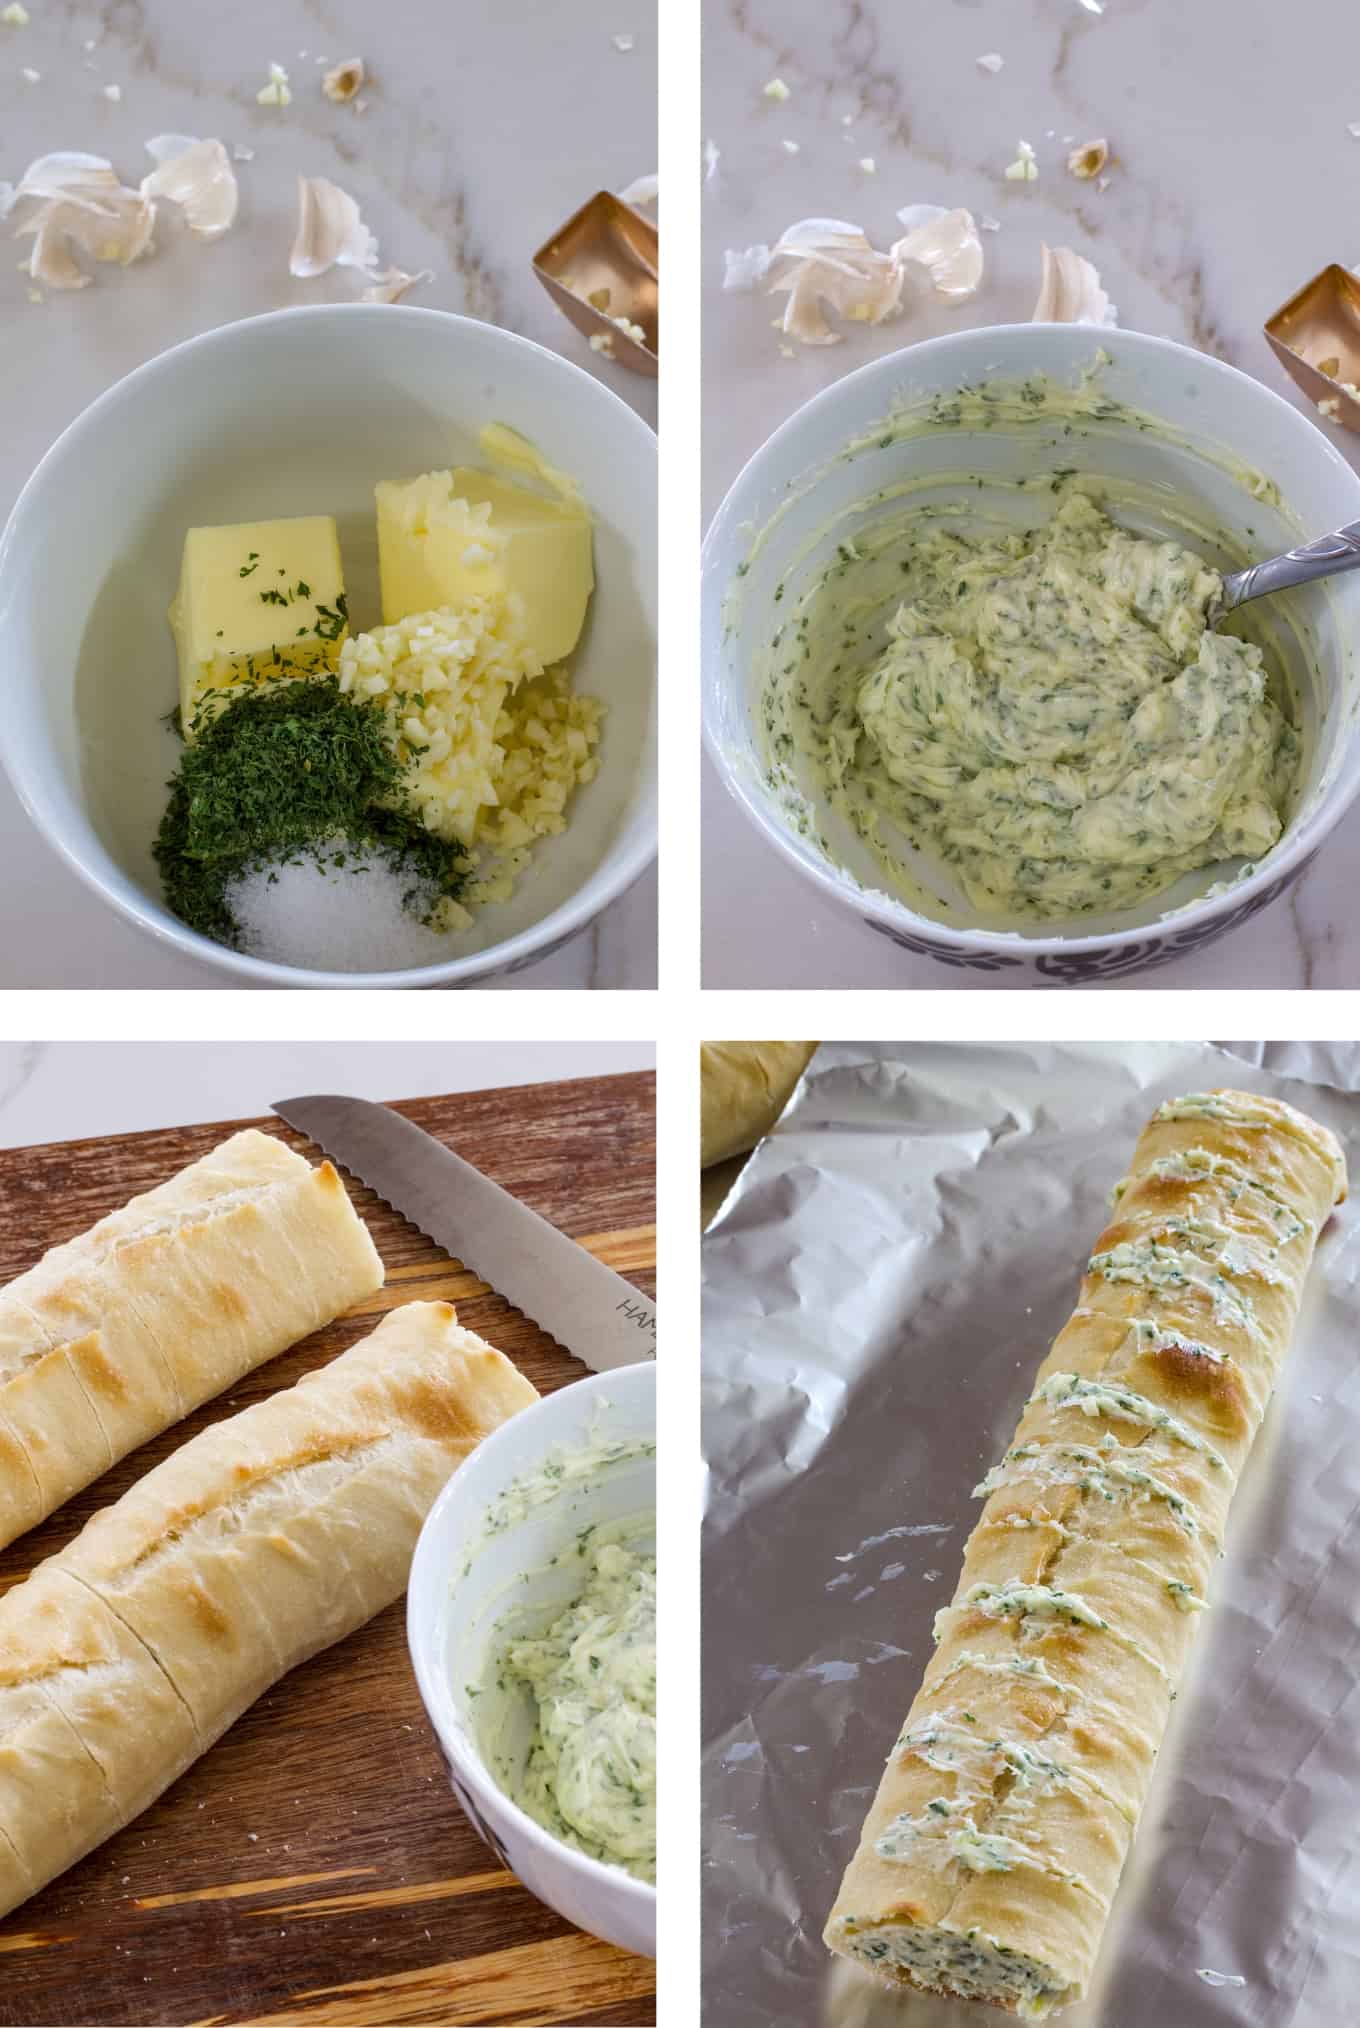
[[170, 515, 349, 738]]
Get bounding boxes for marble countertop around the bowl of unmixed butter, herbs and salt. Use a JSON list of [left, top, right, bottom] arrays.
[[0, 0, 657, 990]]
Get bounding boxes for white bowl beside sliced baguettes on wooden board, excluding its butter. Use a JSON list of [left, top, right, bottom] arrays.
[[405, 1361, 657, 1957]]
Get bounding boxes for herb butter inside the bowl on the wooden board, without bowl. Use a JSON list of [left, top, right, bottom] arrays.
[[503, 1529, 657, 1880]]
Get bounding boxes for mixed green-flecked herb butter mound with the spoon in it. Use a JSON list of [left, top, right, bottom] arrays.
[[766, 493, 1299, 919]]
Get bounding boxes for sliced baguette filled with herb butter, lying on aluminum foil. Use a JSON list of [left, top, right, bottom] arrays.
[[827, 1091, 1346, 2020]]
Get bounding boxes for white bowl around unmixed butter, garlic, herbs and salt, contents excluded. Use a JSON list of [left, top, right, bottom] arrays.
[[0, 304, 657, 986]]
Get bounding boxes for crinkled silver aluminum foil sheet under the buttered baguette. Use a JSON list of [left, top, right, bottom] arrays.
[[703, 1042, 1360, 2028]]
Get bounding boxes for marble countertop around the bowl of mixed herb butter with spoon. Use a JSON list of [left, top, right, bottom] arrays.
[[703, 0, 1360, 992]]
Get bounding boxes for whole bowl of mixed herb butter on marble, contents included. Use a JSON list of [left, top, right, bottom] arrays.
[[703, 324, 1360, 984]]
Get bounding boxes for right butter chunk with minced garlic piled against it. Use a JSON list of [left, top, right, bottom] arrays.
[[377, 466, 596, 667]]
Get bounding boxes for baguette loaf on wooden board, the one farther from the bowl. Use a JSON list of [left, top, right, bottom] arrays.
[[0, 1128, 383, 1545]]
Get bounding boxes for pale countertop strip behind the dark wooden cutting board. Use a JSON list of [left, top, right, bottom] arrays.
[[0, 1042, 657, 1148]]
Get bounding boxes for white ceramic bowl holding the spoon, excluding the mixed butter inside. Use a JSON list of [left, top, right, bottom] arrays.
[[703, 324, 1360, 986]]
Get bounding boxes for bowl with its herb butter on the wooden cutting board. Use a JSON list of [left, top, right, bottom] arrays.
[[407, 1363, 657, 1957]]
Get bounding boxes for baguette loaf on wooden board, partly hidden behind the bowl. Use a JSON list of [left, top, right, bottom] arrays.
[[0, 1302, 537, 1914]]
